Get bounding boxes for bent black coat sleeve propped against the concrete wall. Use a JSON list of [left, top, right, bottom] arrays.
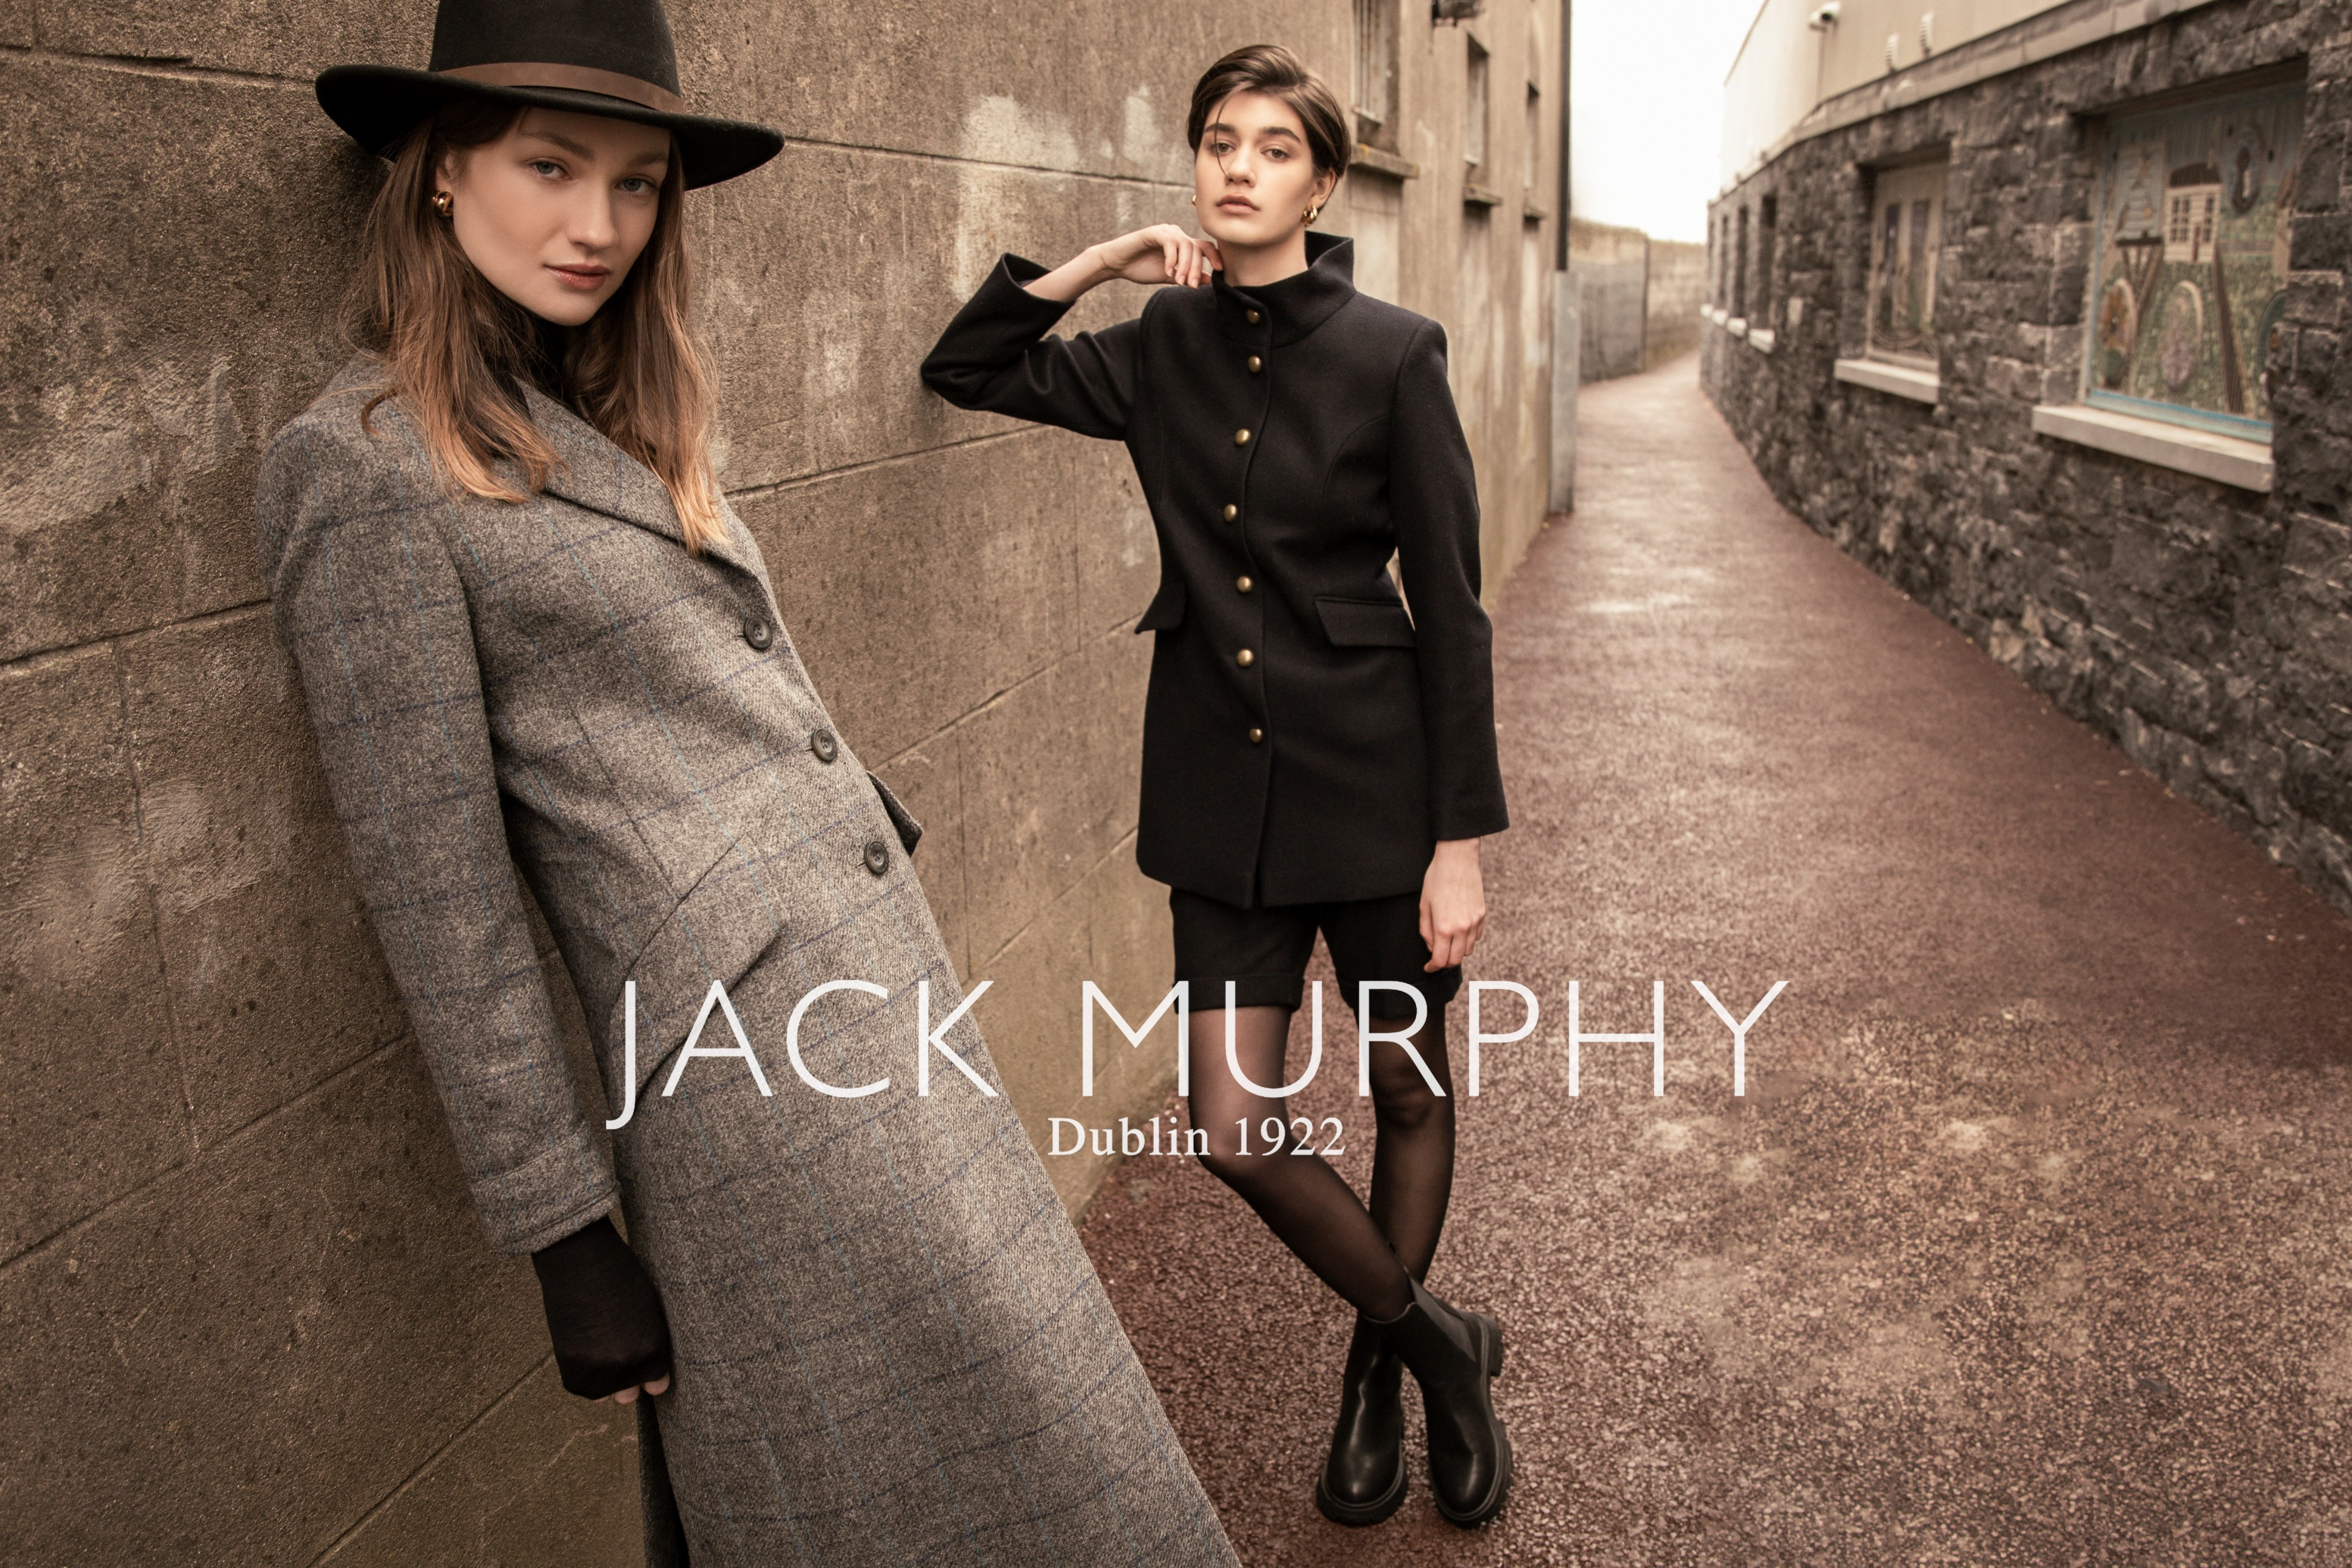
[[922, 256, 1143, 442]]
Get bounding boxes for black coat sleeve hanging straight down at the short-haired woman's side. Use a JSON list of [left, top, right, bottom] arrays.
[[1387, 322, 1510, 840]]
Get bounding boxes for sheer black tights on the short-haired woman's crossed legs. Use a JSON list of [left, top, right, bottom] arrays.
[[1185, 1006, 1454, 1319]]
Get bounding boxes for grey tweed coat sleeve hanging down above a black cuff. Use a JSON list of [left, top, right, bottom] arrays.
[[256, 400, 614, 1253]]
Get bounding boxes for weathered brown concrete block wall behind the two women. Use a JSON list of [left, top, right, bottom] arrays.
[[0, 0, 1559, 1565]]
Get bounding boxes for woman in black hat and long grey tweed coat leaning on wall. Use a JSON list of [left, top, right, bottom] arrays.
[[259, 0, 1235, 1568]]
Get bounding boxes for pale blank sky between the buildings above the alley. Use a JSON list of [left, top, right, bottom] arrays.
[[1569, 0, 1757, 240]]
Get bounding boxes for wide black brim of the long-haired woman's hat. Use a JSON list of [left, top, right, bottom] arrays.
[[315, 66, 783, 191]]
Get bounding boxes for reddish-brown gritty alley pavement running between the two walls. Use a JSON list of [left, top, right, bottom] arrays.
[[1086, 360, 2352, 1568]]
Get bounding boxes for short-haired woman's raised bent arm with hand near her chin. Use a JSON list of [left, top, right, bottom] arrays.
[[922, 223, 1216, 439]]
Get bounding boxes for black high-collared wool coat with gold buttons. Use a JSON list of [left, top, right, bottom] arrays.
[[922, 235, 1507, 905]]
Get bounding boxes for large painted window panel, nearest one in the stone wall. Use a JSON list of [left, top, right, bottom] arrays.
[[2084, 87, 2303, 439]]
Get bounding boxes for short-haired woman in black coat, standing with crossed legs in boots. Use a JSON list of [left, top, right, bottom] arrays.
[[924, 45, 1510, 1526]]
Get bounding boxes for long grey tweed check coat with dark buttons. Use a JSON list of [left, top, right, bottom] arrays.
[[259, 357, 1235, 1568]]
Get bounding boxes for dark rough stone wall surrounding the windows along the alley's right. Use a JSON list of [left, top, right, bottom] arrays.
[[1703, 0, 2352, 912]]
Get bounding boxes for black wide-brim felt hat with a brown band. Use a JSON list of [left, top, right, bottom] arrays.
[[318, 0, 783, 188]]
